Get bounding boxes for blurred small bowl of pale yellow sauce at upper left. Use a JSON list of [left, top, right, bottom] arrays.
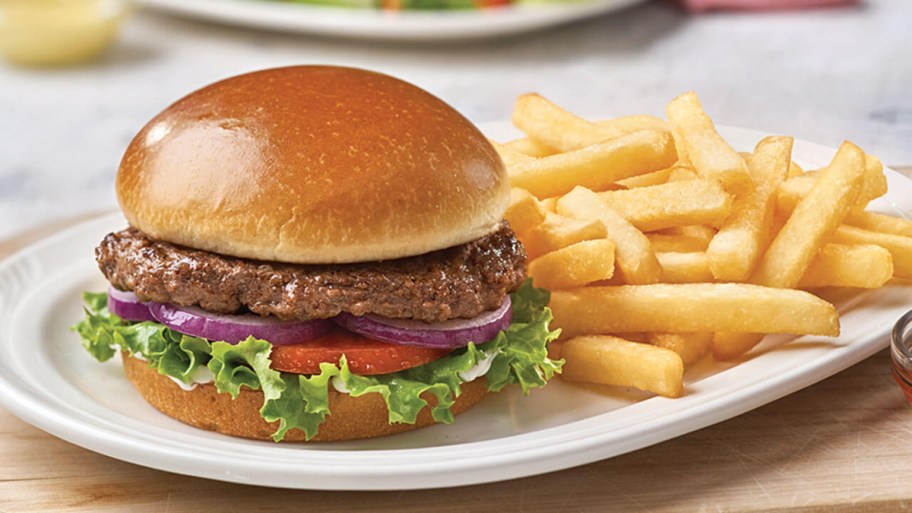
[[0, 0, 132, 66]]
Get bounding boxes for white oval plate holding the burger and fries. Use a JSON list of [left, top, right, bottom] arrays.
[[0, 124, 912, 490]]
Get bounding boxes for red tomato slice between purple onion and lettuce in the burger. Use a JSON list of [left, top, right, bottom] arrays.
[[270, 328, 451, 375]]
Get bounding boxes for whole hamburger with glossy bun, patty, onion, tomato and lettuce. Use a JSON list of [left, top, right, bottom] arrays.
[[74, 66, 560, 441]]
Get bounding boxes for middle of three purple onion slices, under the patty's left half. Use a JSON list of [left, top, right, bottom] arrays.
[[149, 303, 333, 346]]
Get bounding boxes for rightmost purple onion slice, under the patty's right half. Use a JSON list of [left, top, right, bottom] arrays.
[[333, 296, 513, 349]]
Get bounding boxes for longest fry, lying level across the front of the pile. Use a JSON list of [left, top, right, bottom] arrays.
[[550, 283, 839, 337]]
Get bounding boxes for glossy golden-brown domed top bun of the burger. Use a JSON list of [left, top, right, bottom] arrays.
[[117, 66, 509, 264]]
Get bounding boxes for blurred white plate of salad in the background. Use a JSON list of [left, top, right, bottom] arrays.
[[142, 0, 644, 41]]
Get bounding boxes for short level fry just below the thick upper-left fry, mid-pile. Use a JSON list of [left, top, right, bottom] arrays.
[[599, 180, 732, 232]]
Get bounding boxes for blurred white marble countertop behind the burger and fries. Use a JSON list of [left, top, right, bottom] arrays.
[[0, 0, 912, 238]]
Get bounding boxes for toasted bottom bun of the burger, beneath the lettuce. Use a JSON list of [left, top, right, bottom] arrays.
[[123, 353, 488, 442]]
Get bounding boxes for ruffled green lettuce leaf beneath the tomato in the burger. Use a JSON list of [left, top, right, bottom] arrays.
[[71, 280, 563, 442]]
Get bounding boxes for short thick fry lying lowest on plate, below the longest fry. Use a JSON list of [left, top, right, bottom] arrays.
[[561, 336, 684, 397]]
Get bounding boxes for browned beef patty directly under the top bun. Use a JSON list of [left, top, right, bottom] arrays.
[[95, 223, 526, 322]]
